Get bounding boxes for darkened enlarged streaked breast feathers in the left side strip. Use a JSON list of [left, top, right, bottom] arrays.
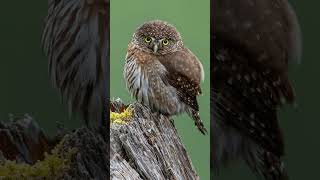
[[42, 0, 109, 124]]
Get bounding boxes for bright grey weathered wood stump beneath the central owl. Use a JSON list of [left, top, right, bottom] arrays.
[[110, 100, 199, 180]]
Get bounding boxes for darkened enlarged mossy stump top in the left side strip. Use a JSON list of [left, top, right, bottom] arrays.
[[0, 116, 110, 180]]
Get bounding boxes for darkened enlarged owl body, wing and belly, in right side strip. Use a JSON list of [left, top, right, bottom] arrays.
[[211, 0, 301, 180]]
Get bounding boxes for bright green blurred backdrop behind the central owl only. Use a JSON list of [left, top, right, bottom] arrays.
[[110, 0, 210, 179]]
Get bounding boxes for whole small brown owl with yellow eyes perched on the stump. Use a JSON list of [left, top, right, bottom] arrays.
[[124, 20, 207, 134]]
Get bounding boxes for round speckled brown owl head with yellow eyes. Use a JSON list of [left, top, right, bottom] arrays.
[[132, 20, 183, 55]]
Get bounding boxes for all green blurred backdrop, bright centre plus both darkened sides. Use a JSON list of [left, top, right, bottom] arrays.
[[0, 0, 320, 180]]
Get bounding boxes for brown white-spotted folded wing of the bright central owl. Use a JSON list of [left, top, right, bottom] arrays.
[[159, 49, 203, 111]]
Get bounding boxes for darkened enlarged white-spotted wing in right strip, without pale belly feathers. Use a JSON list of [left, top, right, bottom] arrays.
[[211, 0, 301, 159]]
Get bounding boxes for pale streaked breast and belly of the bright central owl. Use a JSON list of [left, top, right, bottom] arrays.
[[124, 44, 186, 115]]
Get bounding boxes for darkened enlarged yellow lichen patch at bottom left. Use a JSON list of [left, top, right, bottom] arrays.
[[0, 139, 76, 179]]
